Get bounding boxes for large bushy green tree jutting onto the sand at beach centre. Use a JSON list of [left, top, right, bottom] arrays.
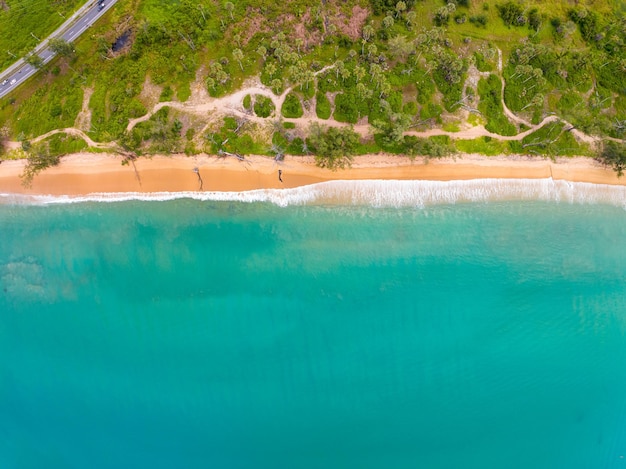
[[309, 123, 360, 170]]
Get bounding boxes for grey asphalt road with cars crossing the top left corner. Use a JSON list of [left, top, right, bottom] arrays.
[[0, 0, 117, 98]]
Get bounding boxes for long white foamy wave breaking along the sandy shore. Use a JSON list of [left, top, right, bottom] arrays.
[[0, 178, 626, 209]]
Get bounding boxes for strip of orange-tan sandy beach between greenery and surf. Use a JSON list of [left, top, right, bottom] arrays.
[[0, 153, 626, 195]]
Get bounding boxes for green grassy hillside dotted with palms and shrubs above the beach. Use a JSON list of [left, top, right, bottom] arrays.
[[0, 0, 626, 166]]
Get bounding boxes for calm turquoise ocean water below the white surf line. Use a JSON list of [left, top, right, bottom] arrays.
[[0, 180, 626, 469]]
